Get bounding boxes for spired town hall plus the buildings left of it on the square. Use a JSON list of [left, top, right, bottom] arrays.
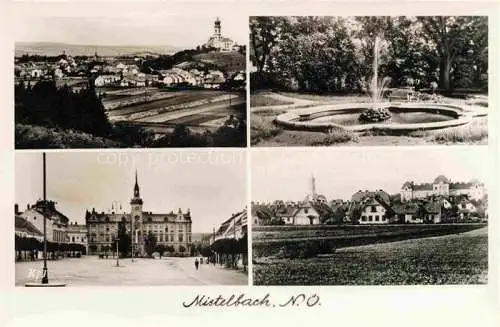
[[15, 174, 192, 256]]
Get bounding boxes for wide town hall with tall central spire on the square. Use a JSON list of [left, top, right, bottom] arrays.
[[85, 172, 192, 256]]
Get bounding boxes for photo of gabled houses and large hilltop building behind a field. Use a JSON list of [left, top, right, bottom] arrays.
[[251, 146, 492, 285]]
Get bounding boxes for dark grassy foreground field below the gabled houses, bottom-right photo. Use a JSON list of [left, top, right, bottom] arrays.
[[253, 227, 488, 285]]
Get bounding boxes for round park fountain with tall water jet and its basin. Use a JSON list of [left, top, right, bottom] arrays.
[[275, 37, 486, 133]]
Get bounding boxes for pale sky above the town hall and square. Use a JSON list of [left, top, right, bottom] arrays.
[[15, 150, 247, 232]]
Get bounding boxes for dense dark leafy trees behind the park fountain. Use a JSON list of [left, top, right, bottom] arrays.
[[250, 16, 488, 92]]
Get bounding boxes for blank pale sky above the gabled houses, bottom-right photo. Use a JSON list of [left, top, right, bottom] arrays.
[[251, 146, 491, 202]]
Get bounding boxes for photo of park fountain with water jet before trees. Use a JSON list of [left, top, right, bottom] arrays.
[[249, 16, 488, 147]]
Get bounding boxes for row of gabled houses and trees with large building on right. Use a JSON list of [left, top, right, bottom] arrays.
[[252, 176, 487, 225]]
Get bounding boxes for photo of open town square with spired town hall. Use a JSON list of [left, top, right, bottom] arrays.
[[14, 149, 248, 287]]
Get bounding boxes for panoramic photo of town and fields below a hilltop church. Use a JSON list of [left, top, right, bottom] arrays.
[[13, 12, 248, 149]]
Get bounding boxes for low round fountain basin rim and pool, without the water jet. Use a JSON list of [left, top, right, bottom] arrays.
[[275, 102, 474, 132]]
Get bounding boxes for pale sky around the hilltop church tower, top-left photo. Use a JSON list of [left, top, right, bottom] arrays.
[[12, 9, 248, 48]]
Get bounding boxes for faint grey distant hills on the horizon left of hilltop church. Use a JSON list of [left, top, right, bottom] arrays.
[[15, 42, 182, 57]]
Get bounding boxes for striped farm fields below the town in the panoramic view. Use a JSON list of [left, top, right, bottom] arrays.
[[100, 88, 246, 134]]
